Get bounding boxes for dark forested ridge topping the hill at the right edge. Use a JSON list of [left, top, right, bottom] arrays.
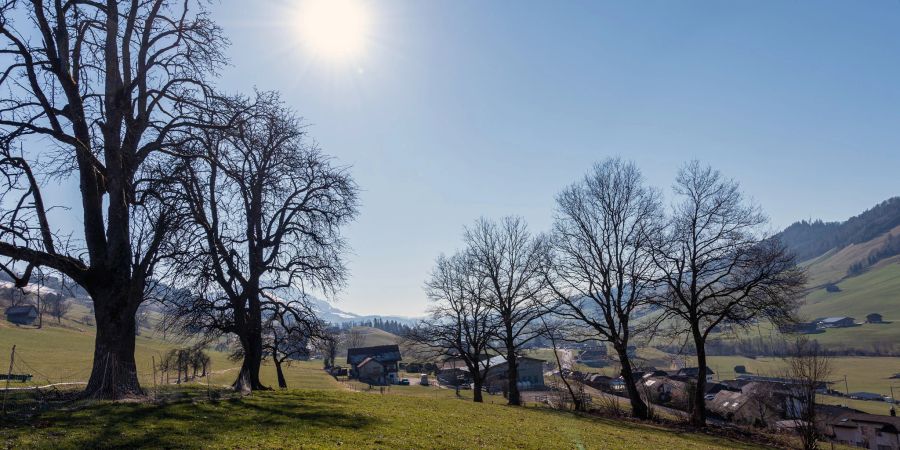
[[778, 197, 900, 261]]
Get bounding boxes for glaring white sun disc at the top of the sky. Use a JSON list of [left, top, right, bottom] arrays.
[[299, 0, 369, 60]]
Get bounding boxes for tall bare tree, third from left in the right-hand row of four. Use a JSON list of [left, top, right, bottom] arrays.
[[548, 159, 661, 419]]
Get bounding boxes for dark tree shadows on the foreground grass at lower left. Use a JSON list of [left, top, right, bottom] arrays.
[[16, 393, 377, 448]]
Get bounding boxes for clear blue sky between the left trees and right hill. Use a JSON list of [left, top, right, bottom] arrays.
[[207, 0, 900, 315]]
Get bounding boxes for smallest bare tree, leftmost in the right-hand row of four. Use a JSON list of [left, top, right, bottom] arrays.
[[407, 253, 498, 402]]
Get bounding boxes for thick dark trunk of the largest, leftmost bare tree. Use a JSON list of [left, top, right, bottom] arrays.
[[84, 291, 143, 400]]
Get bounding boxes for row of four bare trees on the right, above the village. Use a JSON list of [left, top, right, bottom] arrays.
[[409, 158, 805, 426]]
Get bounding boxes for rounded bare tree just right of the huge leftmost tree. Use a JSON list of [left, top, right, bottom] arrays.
[[170, 93, 357, 391]]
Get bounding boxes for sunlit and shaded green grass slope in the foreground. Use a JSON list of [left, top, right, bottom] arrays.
[[0, 362, 768, 449]]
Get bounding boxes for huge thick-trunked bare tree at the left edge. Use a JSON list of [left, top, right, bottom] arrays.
[[0, 0, 225, 398]]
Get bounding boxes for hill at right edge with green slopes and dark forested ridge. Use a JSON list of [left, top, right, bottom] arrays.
[[778, 197, 900, 355]]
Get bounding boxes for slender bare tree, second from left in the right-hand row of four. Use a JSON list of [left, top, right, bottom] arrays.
[[465, 217, 548, 405]]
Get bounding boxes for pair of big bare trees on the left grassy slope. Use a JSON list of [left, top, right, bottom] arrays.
[[0, 0, 358, 399]]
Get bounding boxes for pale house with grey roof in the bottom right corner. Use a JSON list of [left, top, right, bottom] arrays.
[[828, 413, 900, 450]]
